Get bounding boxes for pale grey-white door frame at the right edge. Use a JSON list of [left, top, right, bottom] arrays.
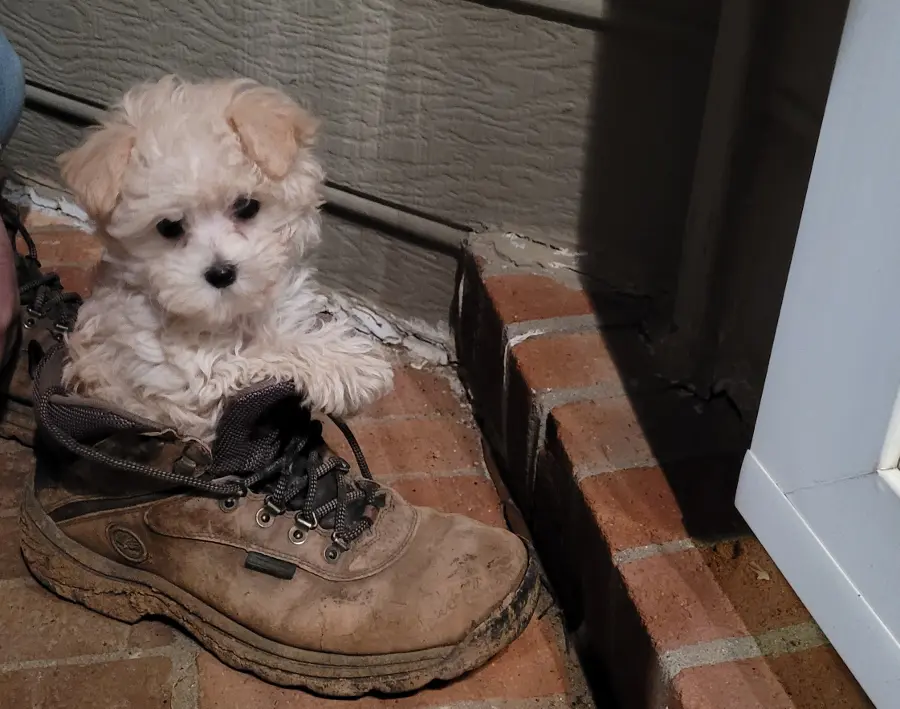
[[736, 0, 900, 709]]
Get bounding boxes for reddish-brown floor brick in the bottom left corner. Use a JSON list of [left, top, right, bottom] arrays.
[[0, 657, 172, 709]]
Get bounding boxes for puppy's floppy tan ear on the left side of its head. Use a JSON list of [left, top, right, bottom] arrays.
[[57, 123, 135, 221]]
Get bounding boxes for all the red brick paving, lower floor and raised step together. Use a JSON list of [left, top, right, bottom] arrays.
[[0, 210, 871, 709]]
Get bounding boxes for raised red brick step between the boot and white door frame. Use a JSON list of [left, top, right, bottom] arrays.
[[454, 234, 872, 709]]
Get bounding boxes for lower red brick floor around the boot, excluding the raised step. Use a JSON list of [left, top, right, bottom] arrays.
[[0, 218, 593, 709]]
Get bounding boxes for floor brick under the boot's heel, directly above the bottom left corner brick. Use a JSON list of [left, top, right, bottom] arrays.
[[0, 583, 166, 663]]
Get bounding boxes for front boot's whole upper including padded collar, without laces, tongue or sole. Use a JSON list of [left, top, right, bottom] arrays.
[[35, 348, 528, 655]]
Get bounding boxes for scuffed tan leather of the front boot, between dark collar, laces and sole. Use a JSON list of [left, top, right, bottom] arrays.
[[60, 493, 527, 654]]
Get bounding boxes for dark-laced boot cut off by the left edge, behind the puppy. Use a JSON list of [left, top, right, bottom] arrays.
[[0, 194, 81, 446]]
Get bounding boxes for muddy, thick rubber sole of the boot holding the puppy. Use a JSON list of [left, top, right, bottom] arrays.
[[20, 477, 541, 697]]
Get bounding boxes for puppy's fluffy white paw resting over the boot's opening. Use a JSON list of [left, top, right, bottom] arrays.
[[303, 353, 394, 416]]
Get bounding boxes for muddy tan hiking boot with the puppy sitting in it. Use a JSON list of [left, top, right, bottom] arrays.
[[21, 346, 540, 696]]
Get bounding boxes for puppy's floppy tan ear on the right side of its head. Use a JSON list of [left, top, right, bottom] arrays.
[[225, 83, 319, 180]]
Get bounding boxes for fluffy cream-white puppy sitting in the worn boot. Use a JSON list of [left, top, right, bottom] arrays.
[[60, 77, 392, 442]]
